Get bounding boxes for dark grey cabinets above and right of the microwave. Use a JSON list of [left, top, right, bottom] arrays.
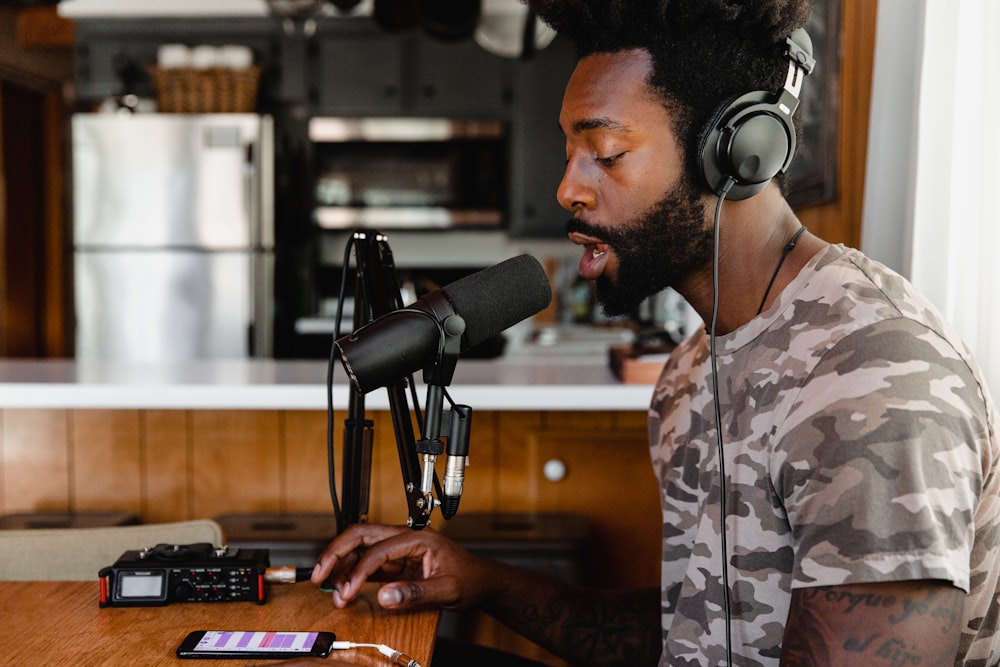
[[312, 25, 576, 238]]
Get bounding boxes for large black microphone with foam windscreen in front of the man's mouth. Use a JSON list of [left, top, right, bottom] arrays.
[[334, 255, 552, 394]]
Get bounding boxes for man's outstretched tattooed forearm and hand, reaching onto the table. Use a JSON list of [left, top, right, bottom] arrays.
[[312, 524, 662, 667]]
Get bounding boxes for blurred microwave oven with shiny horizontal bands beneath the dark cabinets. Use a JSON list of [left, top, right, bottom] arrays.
[[308, 117, 509, 230]]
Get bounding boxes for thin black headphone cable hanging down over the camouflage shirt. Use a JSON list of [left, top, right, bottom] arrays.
[[708, 176, 735, 667]]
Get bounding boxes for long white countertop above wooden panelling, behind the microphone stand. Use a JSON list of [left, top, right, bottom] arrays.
[[0, 349, 652, 410]]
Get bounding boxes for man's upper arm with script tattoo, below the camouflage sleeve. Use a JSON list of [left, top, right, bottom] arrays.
[[781, 580, 965, 667]]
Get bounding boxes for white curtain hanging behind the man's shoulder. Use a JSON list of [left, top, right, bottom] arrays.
[[862, 0, 1000, 398]]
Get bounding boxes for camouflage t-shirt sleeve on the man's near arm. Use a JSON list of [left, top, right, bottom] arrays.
[[772, 319, 989, 591]]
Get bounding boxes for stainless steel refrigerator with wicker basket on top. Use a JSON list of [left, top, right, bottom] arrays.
[[72, 114, 274, 361]]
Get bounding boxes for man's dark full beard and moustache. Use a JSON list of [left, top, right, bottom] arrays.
[[566, 176, 714, 317]]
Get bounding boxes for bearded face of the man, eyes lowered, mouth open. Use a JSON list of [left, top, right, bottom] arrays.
[[558, 50, 712, 315]]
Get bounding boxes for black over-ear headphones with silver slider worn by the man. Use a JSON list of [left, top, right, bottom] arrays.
[[697, 28, 816, 199]]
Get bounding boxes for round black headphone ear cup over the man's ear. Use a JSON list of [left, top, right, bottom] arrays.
[[699, 91, 795, 200]]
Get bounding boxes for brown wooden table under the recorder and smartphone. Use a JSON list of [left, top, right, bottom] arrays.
[[0, 581, 439, 667]]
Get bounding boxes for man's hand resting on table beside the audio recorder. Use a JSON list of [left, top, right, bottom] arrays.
[[312, 524, 491, 609]]
